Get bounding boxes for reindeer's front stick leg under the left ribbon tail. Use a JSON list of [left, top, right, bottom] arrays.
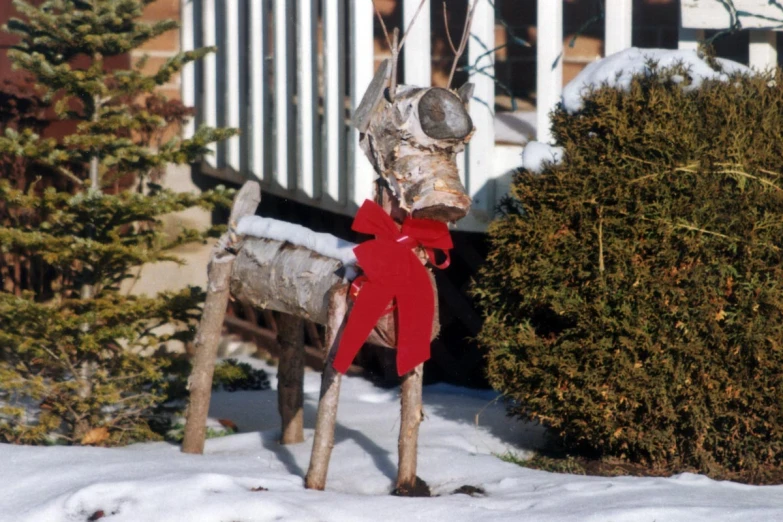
[[305, 285, 348, 490]]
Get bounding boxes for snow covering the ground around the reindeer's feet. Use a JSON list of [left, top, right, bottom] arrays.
[[0, 359, 783, 522]]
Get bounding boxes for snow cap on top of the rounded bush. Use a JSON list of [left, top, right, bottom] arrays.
[[563, 47, 751, 113]]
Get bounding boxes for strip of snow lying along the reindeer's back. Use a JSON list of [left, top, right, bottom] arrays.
[[237, 216, 356, 266]]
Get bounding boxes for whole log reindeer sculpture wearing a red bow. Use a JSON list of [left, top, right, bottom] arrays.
[[183, 2, 475, 495]]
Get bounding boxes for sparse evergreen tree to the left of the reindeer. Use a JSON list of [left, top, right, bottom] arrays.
[[0, 0, 236, 444]]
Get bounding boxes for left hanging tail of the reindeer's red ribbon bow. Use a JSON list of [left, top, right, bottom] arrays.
[[332, 281, 394, 373]]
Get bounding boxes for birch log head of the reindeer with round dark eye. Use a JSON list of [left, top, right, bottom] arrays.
[[354, 60, 475, 222]]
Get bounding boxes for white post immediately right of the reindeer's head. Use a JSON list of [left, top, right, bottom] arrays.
[[466, 0, 495, 214]]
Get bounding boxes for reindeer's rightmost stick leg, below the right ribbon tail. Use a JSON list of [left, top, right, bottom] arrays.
[[396, 364, 424, 495]]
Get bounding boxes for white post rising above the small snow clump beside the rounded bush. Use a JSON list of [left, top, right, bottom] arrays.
[[536, 0, 563, 143]]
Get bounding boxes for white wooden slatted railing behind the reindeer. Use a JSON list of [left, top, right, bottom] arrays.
[[181, 0, 777, 231]]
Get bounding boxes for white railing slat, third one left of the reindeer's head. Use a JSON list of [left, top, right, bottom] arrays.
[[296, 0, 321, 197]]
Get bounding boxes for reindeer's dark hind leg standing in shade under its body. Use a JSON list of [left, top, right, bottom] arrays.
[[277, 314, 305, 444]]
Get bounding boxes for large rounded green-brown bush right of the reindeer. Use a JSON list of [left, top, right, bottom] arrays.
[[474, 63, 783, 478]]
